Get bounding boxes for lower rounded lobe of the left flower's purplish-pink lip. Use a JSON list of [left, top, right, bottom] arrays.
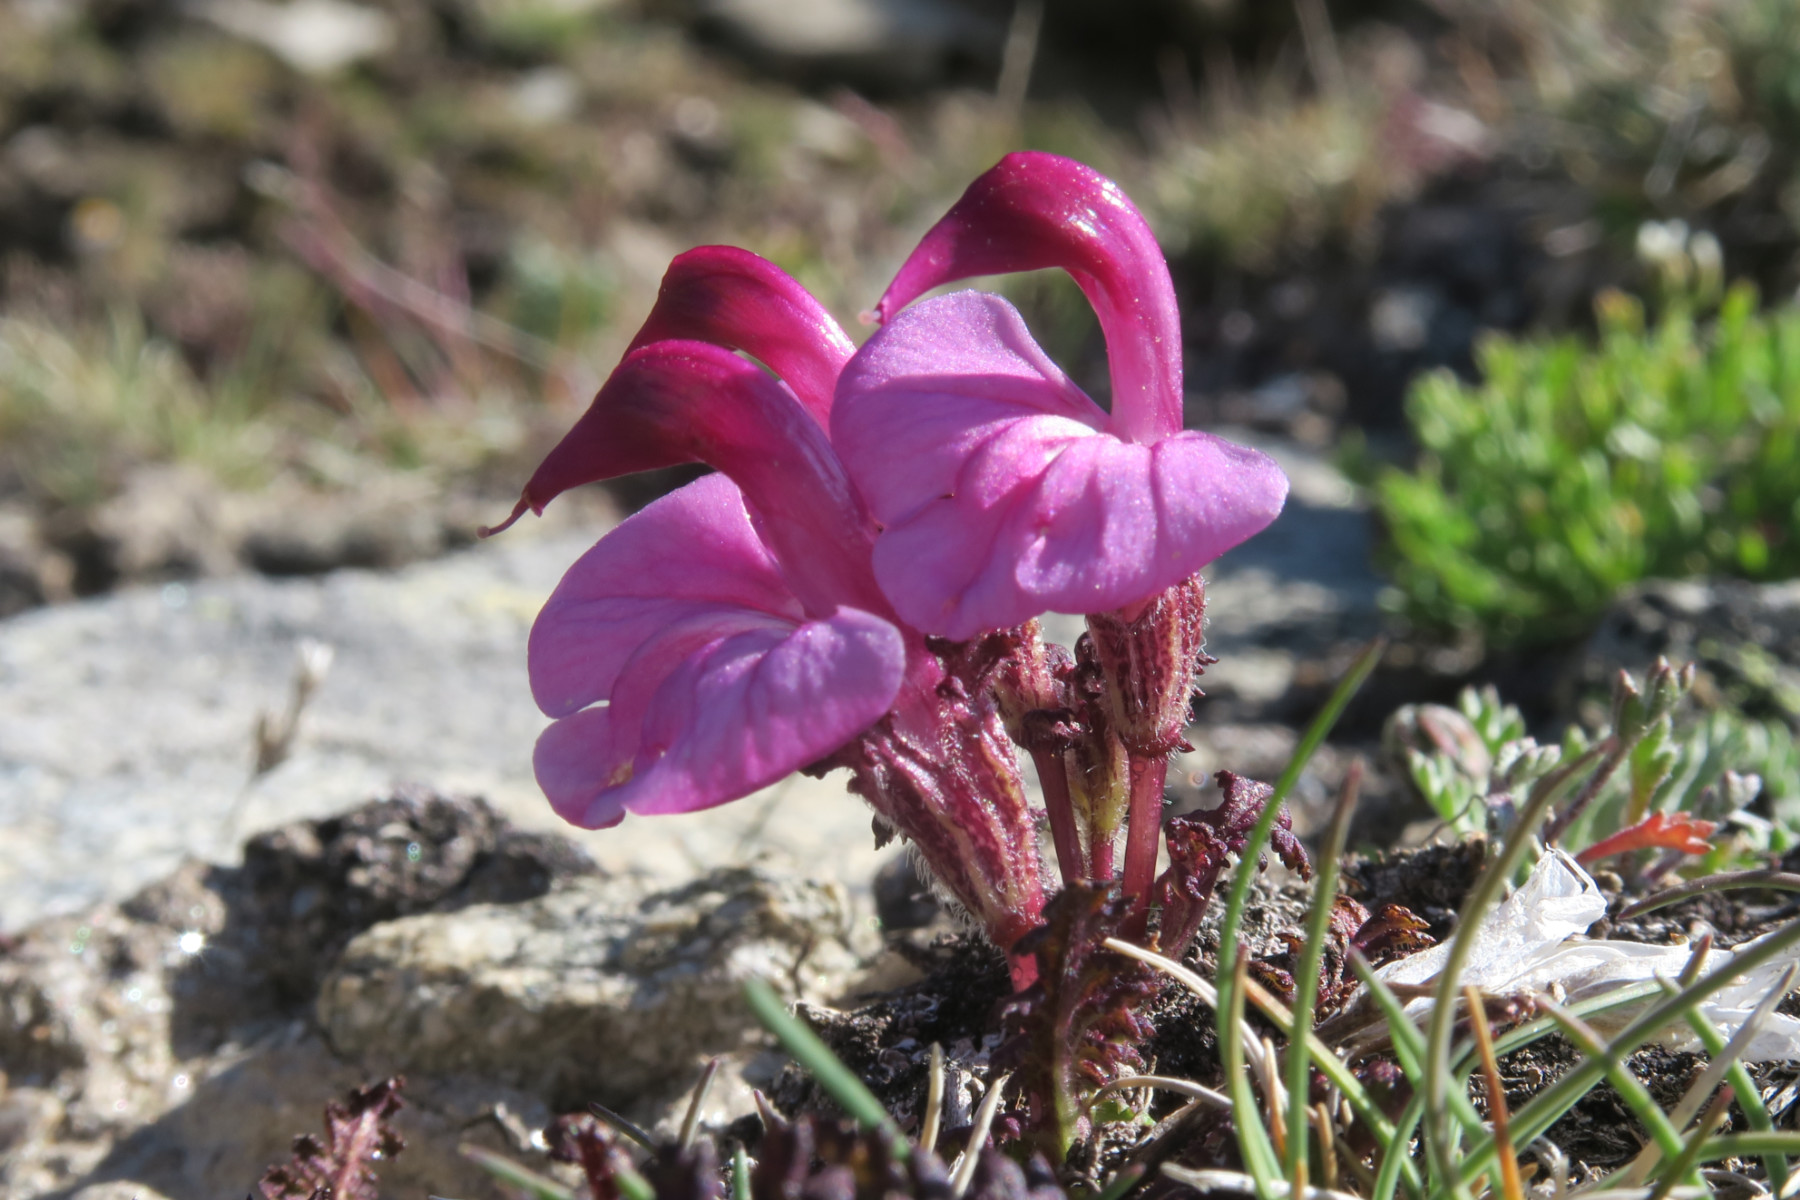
[[535, 608, 905, 828]]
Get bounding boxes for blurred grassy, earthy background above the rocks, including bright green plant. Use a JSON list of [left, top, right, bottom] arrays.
[[0, 0, 1800, 683]]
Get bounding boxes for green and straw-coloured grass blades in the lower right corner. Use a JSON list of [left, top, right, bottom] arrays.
[[1165, 666, 1800, 1200]]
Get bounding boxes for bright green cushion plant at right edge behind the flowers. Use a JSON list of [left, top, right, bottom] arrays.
[[1375, 286, 1800, 644]]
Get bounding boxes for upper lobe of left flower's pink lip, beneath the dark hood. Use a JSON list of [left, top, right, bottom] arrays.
[[529, 475, 805, 716]]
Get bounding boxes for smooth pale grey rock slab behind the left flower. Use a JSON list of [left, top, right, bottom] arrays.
[[0, 506, 892, 930]]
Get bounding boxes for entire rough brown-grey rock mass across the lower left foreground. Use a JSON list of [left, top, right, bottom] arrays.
[[0, 795, 868, 1198]]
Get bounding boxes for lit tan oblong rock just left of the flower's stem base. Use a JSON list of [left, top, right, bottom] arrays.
[[317, 869, 873, 1108]]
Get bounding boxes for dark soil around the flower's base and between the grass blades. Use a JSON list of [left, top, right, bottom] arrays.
[[776, 840, 1800, 1182]]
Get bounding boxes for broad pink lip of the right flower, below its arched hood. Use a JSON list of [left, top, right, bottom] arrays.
[[832, 291, 1287, 640]]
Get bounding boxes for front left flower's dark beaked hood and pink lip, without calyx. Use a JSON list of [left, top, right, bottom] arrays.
[[529, 342, 907, 828]]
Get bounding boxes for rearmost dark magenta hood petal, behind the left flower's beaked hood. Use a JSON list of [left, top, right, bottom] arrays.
[[630, 246, 857, 426]]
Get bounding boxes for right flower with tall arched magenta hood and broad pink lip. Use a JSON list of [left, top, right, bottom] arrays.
[[832, 153, 1287, 640]]
